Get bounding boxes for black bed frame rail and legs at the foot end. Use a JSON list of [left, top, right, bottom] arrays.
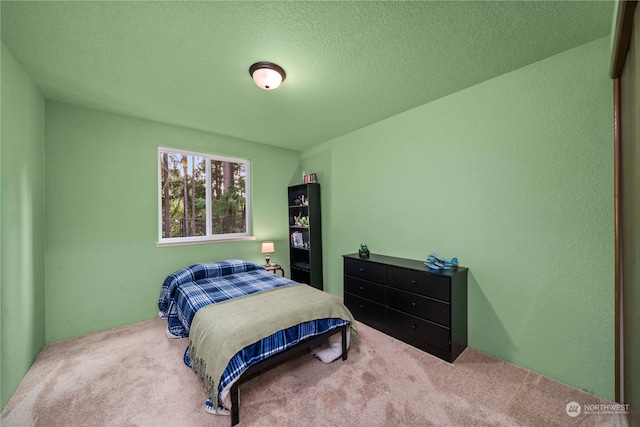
[[231, 325, 349, 426]]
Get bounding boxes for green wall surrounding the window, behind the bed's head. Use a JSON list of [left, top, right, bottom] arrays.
[[45, 101, 300, 342]]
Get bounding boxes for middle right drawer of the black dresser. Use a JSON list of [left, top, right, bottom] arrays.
[[387, 288, 451, 326]]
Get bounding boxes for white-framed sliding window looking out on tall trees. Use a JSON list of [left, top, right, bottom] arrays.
[[158, 148, 252, 245]]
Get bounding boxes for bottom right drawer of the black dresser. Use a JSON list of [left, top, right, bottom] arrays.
[[387, 308, 450, 351]]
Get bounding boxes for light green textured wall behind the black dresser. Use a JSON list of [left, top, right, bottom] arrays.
[[302, 37, 614, 399]]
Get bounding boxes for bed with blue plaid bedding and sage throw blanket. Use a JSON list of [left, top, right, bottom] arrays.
[[158, 259, 356, 425]]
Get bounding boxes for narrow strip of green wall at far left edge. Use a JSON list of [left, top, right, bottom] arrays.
[[0, 44, 45, 408]]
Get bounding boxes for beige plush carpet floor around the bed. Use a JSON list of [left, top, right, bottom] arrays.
[[0, 319, 627, 427]]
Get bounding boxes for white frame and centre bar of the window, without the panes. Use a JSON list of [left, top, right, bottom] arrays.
[[156, 147, 255, 247]]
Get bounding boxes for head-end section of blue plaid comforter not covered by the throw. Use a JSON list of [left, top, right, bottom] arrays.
[[158, 259, 297, 338]]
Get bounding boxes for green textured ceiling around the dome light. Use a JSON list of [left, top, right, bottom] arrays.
[[0, 0, 613, 150]]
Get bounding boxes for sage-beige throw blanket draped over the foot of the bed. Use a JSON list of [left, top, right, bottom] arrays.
[[189, 284, 357, 406]]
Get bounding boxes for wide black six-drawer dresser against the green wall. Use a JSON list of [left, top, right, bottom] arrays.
[[343, 254, 468, 362]]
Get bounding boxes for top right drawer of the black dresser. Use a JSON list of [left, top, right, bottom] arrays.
[[387, 267, 451, 302]]
